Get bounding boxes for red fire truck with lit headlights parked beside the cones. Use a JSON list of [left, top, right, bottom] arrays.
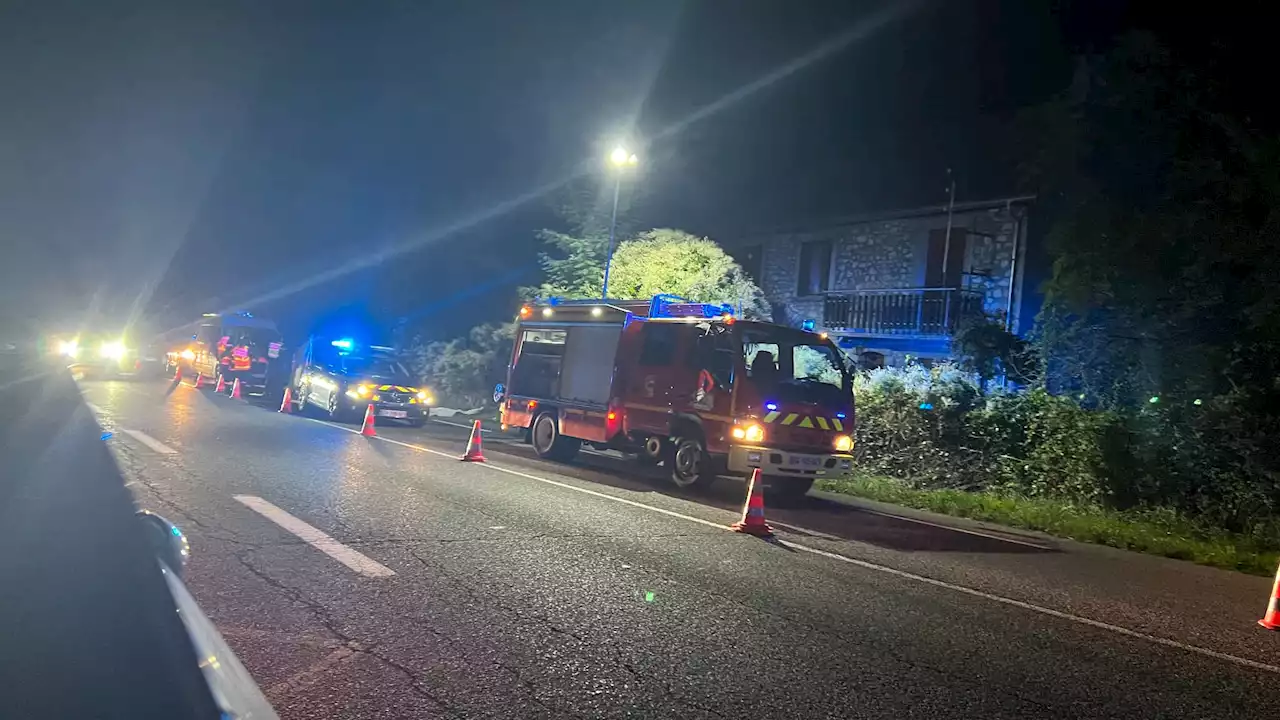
[[494, 295, 854, 496]]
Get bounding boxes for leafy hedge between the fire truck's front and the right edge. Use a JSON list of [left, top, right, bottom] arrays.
[[854, 365, 1280, 542]]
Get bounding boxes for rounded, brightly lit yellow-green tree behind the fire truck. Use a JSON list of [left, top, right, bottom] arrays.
[[609, 228, 771, 319]]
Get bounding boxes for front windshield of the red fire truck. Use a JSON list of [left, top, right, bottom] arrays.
[[742, 329, 852, 402]]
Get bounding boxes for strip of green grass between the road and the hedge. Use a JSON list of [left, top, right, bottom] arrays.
[[814, 477, 1280, 577]]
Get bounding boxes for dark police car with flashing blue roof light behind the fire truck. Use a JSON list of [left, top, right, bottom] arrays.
[[291, 338, 435, 428]]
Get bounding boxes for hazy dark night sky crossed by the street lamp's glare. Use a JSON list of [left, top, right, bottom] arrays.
[[0, 0, 1121, 337]]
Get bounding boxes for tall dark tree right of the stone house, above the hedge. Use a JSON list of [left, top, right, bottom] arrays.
[[1018, 33, 1280, 406]]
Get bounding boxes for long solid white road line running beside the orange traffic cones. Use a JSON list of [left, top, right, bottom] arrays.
[[308, 418, 1280, 675]]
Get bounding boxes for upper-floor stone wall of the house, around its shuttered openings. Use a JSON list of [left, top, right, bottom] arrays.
[[756, 199, 1025, 331]]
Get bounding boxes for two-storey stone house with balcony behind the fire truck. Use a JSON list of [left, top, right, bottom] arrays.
[[727, 197, 1034, 366]]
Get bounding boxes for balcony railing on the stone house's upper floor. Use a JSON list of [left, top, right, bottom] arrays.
[[822, 288, 982, 337]]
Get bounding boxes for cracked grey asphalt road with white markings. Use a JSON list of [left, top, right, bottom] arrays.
[[82, 371, 1280, 719]]
